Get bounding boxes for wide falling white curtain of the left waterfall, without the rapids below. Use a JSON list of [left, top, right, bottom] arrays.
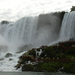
[[4, 17, 37, 44]]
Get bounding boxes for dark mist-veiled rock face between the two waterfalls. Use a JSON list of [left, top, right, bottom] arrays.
[[36, 12, 65, 46]]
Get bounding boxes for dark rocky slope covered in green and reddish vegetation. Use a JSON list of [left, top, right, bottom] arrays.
[[15, 40, 75, 73]]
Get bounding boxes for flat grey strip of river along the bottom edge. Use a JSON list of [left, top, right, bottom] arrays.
[[0, 72, 75, 75]]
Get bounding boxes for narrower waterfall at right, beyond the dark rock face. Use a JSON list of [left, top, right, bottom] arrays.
[[59, 11, 75, 40]]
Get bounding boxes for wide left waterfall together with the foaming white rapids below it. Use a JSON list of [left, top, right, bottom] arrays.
[[0, 17, 38, 71]]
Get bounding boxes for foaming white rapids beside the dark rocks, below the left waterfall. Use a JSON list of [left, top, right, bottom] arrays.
[[0, 51, 25, 72]]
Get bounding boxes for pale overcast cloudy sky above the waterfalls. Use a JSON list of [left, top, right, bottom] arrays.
[[0, 0, 75, 21]]
